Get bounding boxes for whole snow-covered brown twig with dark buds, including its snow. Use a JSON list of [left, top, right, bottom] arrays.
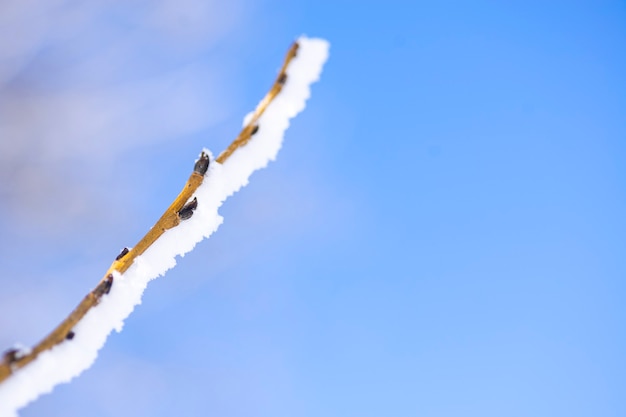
[[0, 37, 329, 416]]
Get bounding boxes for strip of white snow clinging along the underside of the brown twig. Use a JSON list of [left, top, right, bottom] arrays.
[[0, 37, 329, 417]]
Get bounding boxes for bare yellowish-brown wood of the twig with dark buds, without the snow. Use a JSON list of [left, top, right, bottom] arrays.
[[0, 42, 298, 383]]
